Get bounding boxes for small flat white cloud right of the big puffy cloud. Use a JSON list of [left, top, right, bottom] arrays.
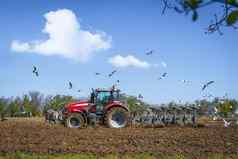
[[109, 55, 151, 68]]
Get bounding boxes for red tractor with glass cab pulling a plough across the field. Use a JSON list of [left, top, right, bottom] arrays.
[[63, 88, 129, 128]]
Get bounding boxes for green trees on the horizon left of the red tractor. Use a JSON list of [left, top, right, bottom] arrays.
[[0, 91, 77, 118]]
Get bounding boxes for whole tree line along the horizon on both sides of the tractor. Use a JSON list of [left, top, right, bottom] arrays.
[[0, 91, 238, 118]]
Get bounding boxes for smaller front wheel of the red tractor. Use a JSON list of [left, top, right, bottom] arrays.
[[65, 113, 85, 129]]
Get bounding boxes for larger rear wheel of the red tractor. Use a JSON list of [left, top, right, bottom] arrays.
[[105, 107, 129, 128]]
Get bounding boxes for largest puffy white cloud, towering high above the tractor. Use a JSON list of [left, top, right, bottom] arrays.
[[11, 9, 111, 61]]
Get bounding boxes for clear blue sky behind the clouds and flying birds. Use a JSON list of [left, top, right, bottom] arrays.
[[0, 0, 238, 103]]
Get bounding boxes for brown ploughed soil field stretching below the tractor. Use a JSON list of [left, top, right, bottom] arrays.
[[0, 118, 238, 158]]
